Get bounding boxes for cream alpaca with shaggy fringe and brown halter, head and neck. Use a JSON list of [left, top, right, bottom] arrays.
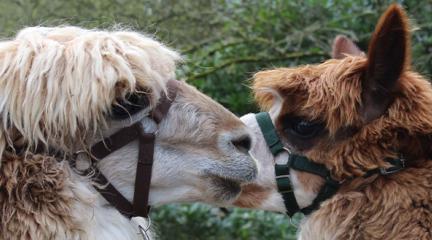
[[0, 27, 257, 240]]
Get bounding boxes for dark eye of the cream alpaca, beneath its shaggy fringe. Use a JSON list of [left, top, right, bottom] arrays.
[[112, 93, 149, 119]]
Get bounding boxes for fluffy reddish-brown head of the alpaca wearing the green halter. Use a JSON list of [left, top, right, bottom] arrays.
[[240, 5, 432, 210]]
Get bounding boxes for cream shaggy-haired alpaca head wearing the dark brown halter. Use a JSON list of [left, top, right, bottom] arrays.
[[0, 27, 257, 208]]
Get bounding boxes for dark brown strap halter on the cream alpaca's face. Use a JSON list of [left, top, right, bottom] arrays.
[[74, 80, 179, 218]]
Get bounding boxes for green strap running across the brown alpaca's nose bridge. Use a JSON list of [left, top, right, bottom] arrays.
[[255, 112, 284, 156]]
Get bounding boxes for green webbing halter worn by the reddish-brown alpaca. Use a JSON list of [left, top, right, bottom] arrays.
[[255, 112, 405, 217]]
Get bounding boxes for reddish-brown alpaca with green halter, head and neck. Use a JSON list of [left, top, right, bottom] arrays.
[[248, 5, 432, 239]]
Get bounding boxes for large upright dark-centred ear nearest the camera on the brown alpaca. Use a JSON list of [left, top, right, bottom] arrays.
[[361, 4, 410, 122]]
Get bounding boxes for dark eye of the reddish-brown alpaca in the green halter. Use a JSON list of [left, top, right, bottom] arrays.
[[285, 118, 325, 138]]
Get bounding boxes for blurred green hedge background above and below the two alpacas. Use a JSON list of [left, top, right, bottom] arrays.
[[0, 0, 432, 240]]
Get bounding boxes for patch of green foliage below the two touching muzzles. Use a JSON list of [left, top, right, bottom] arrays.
[[152, 204, 296, 240]]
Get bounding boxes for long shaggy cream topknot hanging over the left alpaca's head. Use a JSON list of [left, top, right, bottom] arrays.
[[0, 27, 180, 161]]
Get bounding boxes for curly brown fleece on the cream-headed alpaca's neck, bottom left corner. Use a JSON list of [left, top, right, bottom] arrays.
[[0, 154, 78, 239]]
